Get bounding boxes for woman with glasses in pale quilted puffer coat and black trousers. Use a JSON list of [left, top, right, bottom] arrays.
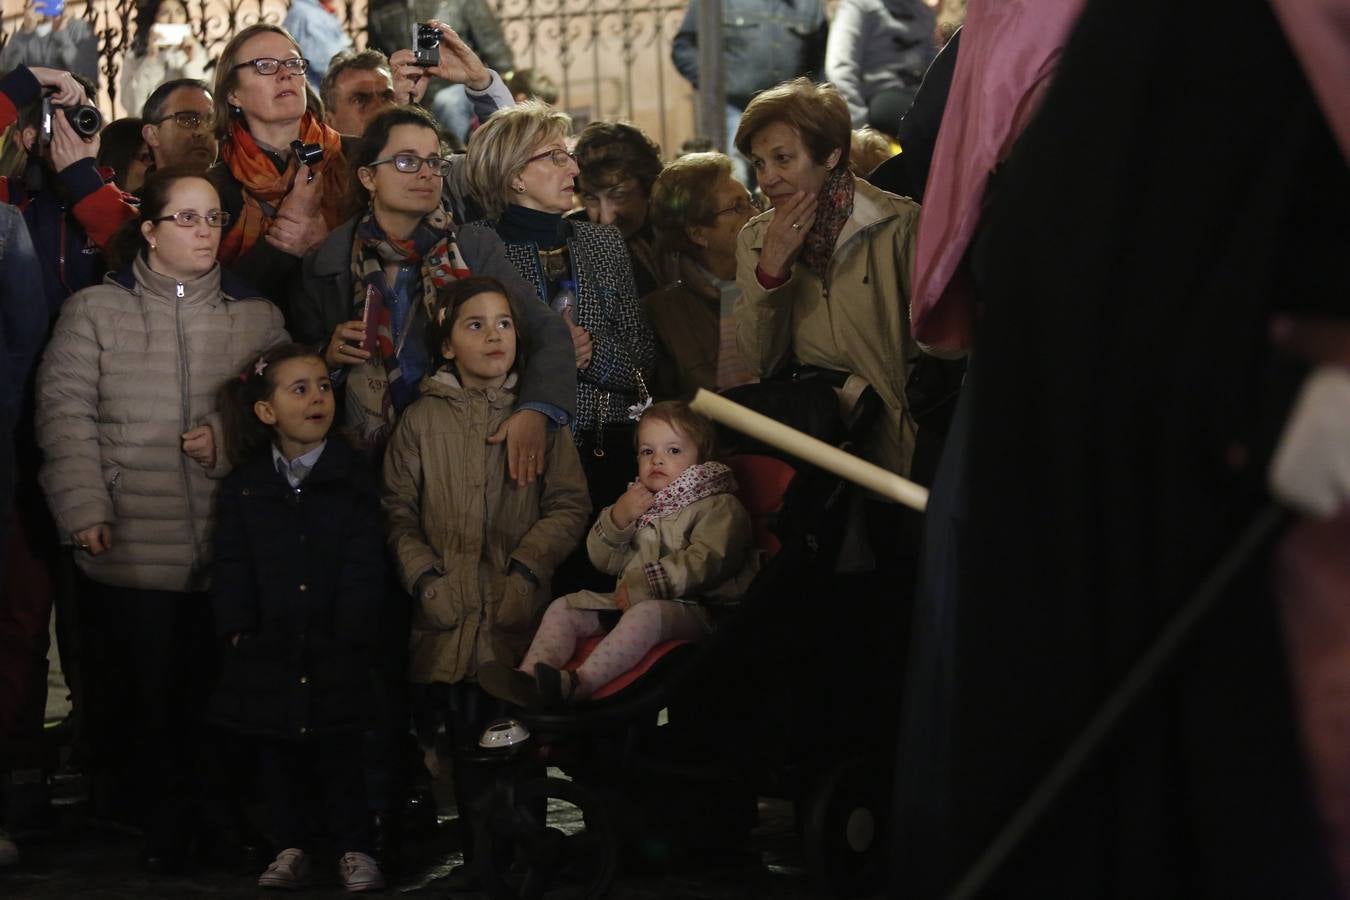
[[36, 169, 286, 872]]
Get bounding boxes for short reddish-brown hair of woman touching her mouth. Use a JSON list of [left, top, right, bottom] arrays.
[[736, 77, 853, 166]]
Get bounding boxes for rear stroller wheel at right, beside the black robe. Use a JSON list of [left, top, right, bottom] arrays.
[[799, 758, 891, 897]]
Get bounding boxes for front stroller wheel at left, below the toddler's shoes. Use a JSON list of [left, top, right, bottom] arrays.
[[477, 779, 618, 900]]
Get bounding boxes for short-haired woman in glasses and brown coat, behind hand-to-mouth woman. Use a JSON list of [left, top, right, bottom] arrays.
[[643, 152, 760, 399]]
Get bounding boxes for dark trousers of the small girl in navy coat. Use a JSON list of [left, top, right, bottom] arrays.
[[258, 733, 373, 853]]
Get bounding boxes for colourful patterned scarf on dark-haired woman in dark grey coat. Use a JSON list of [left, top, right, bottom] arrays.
[[351, 206, 470, 410]]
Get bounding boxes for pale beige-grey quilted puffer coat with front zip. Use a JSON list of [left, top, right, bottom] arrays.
[[36, 259, 288, 591]]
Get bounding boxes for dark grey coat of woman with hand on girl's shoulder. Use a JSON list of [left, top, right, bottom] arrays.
[[290, 219, 576, 416]]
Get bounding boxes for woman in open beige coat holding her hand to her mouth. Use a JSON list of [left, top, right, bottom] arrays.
[[736, 78, 919, 475]]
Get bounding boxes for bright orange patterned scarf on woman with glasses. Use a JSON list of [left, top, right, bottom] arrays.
[[217, 112, 348, 264]]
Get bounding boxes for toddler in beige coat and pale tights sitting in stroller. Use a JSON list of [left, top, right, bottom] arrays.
[[479, 402, 759, 708]]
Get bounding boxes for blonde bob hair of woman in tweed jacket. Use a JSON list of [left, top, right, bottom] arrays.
[[464, 100, 572, 219]]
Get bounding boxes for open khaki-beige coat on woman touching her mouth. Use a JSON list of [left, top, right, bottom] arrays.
[[736, 171, 919, 475]]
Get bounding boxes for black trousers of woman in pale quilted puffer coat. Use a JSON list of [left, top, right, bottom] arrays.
[[78, 578, 216, 853]]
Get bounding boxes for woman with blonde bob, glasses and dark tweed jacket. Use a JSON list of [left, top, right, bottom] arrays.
[[462, 101, 655, 591]]
